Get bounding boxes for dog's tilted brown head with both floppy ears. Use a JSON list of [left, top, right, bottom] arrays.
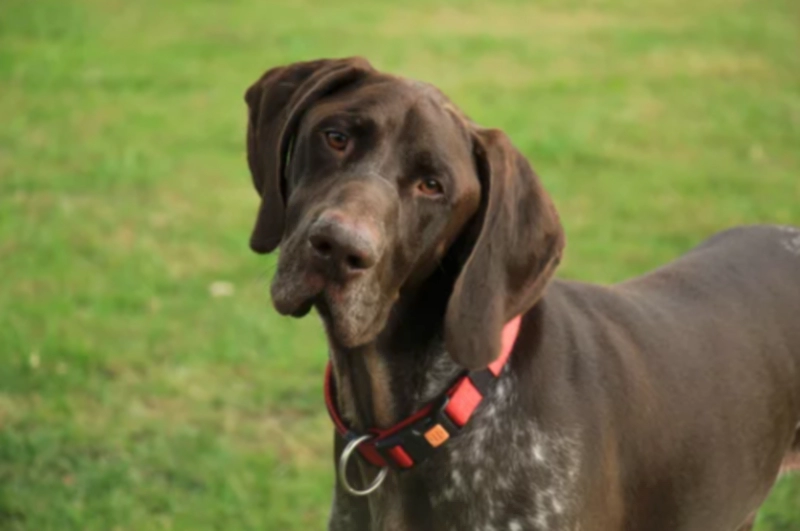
[[245, 58, 564, 368]]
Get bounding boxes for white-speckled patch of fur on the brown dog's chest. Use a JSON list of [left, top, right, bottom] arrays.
[[429, 406, 580, 531]]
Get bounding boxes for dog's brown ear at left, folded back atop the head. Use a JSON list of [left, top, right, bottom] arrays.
[[244, 57, 374, 253]]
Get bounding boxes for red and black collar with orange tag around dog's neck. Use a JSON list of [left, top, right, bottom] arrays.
[[325, 316, 521, 469]]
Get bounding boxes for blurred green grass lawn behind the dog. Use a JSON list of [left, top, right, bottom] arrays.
[[0, 0, 800, 531]]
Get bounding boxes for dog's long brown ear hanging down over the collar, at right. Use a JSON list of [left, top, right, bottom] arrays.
[[445, 128, 564, 369]]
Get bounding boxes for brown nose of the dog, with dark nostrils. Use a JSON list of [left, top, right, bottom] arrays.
[[308, 212, 378, 277]]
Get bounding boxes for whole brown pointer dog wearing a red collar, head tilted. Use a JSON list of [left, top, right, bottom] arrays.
[[246, 58, 800, 531]]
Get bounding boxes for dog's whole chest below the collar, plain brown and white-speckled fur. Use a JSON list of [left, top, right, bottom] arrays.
[[334, 380, 581, 531]]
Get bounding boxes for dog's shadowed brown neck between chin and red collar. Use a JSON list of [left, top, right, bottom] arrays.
[[329, 272, 462, 432]]
